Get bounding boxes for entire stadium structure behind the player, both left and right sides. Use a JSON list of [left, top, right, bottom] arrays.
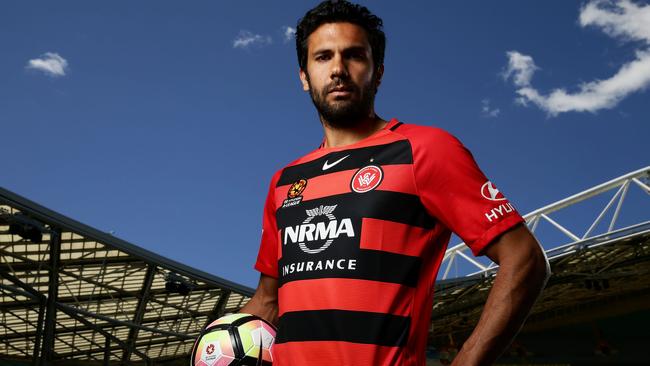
[[0, 167, 650, 365]]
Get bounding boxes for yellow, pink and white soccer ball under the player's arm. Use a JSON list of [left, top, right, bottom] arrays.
[[190, 313, 276, 366]]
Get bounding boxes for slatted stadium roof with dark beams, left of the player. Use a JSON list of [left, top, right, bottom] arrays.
[[0, 188, 253, 364]]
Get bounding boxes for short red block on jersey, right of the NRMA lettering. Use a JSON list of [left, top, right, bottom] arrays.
[[359, 217, 431, 257]]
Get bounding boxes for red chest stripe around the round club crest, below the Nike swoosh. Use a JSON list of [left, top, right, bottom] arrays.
[[275, 163, 417, 207]]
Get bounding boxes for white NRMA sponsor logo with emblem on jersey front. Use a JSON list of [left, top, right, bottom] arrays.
[[284, 205, 354, 254]]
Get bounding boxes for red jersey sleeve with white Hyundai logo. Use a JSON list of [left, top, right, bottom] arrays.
[[413, 128, 524, 255]]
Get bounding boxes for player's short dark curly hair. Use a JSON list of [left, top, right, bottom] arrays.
[[296, 0, 386, 71]]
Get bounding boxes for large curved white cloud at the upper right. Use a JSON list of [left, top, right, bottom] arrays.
[[503, 0, 650, 116]]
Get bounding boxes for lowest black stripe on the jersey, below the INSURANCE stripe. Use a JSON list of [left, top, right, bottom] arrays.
[[275, 308, 411, 347]]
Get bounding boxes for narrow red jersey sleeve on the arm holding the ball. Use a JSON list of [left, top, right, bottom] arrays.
[[255, 172, 280, 278]]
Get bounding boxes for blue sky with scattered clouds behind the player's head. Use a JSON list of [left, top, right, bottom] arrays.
[[0, 0, 650, 286]]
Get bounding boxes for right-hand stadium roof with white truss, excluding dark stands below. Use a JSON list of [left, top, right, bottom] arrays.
[[431, 167, 650, 345]]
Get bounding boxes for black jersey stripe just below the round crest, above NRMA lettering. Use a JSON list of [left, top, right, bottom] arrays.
[[276, 190, 436, 229]]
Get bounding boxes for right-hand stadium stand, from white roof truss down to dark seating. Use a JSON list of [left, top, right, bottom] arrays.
[[429, 167, 650, 365]]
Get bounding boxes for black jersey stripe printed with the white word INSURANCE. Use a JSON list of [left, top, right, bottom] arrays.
[[278, 249, 422, 288]]
